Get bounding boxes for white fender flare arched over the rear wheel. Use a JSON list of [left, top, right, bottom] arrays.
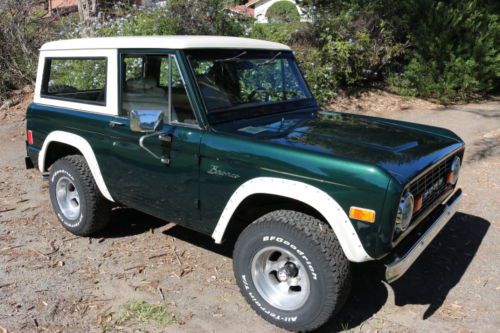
[[38, 131, 114, 202]]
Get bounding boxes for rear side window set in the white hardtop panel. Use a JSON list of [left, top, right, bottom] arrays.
[[42, 58, 107, 105]]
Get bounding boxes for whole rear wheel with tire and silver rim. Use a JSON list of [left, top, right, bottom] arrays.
[[49, 155, 111, 236]]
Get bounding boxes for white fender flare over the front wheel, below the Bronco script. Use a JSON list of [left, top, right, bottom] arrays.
[[212, 177, 373, 262]]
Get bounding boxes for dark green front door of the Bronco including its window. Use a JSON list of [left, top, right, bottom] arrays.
[[103, 51, 203, 226]]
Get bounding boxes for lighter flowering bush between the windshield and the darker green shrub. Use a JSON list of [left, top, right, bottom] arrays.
[[292, 0, 407, 103]]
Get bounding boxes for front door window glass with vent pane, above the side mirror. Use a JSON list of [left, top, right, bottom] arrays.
[[121, 54, 198, 124]]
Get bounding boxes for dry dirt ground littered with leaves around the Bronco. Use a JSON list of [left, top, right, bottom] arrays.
[[0, 93, 500, 333]]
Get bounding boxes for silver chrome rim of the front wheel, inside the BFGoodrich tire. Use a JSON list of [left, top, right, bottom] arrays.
[[252, 246, 311, 311]]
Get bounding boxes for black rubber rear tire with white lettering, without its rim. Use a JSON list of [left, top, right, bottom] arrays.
[[49, 155, 111, 237]]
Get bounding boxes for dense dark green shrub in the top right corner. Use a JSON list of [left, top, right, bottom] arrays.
[[389, 0, 500, 103]]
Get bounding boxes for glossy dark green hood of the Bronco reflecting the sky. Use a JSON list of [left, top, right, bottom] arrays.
[[216, 111, 463, 184]]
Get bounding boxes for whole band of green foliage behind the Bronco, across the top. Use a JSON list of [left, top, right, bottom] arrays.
[[0, 0, 500, 103]]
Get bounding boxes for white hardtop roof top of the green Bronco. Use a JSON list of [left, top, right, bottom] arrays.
[[41, 36, 290, 51]]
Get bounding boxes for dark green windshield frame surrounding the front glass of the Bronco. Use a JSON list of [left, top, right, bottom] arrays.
[[183, 48, 318, 124]]
